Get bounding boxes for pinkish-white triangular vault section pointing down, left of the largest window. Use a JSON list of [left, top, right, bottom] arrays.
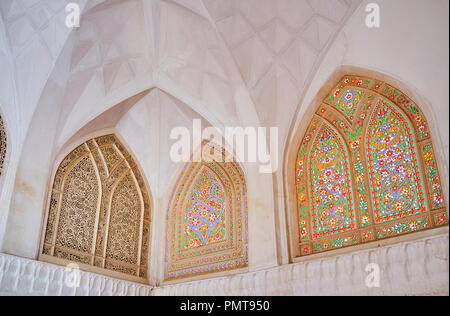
[[204, 0, 359, 137]]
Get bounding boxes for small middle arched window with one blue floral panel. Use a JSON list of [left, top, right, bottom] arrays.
[[164, 141, 248, 280]]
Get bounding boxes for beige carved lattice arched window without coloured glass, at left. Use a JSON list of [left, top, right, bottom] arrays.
[[42, 135, 151, 279]]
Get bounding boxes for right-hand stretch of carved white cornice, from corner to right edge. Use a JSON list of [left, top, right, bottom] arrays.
[[153, 230, 449, 296]]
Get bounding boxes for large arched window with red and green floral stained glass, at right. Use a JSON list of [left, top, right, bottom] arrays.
[[296, 76, 448, 256]]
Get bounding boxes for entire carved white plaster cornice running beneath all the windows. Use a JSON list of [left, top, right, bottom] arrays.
[[0, 229, 449, 296]]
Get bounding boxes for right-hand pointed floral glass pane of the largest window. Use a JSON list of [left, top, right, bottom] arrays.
[[366, 101, 425, 223]]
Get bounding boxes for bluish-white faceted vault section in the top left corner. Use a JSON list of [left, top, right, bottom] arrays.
[[0, 0, 88, 139]]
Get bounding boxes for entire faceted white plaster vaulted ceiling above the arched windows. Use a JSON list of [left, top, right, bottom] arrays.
[[0, 0, 360, 154]]
